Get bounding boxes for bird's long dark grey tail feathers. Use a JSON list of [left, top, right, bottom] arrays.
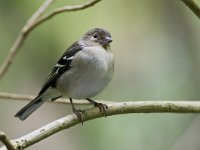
[[15, 96, 45, 121]]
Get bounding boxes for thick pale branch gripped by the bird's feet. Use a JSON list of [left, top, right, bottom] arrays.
[[0, 101, 200, 150]]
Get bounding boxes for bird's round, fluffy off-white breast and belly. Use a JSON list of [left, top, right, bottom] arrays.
[[57, 47, 113, 99]]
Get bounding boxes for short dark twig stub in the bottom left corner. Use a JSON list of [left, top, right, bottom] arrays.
[[0, 131, 16, 150]]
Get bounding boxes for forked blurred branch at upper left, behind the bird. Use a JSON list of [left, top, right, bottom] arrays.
[[0, 0, 101, 79]]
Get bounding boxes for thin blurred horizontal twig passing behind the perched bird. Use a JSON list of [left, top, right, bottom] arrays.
[[0, 92, 113, 105]]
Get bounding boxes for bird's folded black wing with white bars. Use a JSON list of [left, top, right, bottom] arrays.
[[39, 42, 83, 95]]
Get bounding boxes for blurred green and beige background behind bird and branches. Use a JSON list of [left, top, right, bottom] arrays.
[[0, 0, 200, 150]]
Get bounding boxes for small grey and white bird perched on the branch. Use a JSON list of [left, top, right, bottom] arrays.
[[15, 28, 114, 122]]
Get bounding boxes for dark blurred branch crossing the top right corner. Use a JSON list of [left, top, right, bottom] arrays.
[[181, 0, 200, 19]]
